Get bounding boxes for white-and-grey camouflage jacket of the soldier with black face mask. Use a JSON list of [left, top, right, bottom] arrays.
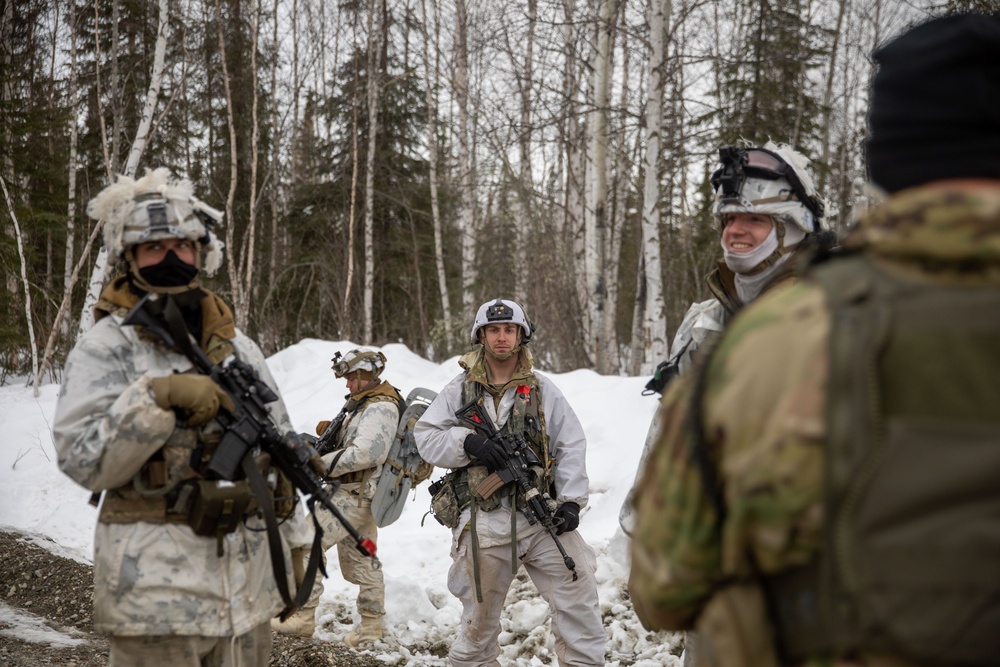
[[53, 290, 302, 637]]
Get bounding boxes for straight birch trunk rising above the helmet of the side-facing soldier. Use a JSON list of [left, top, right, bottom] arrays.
[[362, 0, 382, 345]]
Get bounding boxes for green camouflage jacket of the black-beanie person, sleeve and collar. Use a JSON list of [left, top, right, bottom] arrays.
[[630, 185, 1000, 664]]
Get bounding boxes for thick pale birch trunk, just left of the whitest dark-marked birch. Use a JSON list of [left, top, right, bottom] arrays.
[[584, 0, 614, 372]]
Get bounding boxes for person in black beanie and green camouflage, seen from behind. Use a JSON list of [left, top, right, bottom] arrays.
[[629, 15, 1000, 666]]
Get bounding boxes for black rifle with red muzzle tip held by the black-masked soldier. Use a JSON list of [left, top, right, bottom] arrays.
[[123, 292, 375, 560]]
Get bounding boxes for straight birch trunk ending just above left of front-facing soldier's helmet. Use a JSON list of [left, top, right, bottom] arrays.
[[454, 0, 478, 321]]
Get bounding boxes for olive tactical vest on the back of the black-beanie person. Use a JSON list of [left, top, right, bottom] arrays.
[[765, 254, 1000, 666]]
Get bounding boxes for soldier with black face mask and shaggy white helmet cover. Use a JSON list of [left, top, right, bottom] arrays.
[[53, 169, 310, 667]]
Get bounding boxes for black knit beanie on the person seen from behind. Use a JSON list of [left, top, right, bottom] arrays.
[[865, 14, 1000, 192]]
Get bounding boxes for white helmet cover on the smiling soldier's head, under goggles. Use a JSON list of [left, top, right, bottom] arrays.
[[714, 141, 825, 234]]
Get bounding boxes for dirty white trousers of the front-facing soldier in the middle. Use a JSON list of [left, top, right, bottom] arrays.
[[448, 531, 607, 667]]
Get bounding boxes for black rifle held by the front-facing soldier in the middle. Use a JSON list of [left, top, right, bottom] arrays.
[[455, 399, 577, 581]]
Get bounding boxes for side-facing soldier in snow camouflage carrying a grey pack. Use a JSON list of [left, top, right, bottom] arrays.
[[272, 350, 403, 646]]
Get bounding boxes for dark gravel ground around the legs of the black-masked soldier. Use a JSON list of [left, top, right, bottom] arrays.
[[0, 532, 385, 667]]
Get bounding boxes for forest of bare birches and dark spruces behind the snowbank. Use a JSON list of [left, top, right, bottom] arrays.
[[0, 0, 998, 386]]
